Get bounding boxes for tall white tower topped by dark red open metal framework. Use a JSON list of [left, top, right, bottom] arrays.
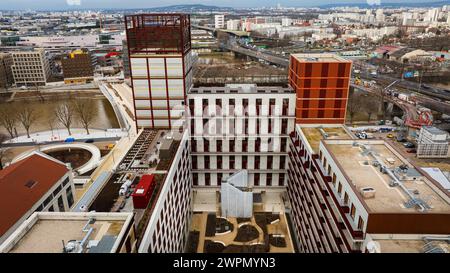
[[125, 14, 192, 129]]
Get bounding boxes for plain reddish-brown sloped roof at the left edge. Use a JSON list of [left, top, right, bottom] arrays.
[[0, 154, 69, 236]]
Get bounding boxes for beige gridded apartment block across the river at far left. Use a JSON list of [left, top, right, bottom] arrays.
[[11, 49, 51, 86]]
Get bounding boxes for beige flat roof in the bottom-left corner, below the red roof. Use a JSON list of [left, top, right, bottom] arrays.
[[0, 212, 133, 253]]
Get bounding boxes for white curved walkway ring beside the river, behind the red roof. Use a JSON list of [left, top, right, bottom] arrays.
[[12, 142, 101, 174]]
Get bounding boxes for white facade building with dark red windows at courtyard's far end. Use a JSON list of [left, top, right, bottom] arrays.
[[188, 85, 295, 188]]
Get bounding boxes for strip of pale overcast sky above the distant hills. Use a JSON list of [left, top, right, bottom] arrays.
[[0, 0, 444, 10]]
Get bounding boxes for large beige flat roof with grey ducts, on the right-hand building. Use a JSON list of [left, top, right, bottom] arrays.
[[324, 140, 450, 213]]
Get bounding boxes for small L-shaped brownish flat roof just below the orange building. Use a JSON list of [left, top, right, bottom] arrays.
[[297, 125, 353, 154]]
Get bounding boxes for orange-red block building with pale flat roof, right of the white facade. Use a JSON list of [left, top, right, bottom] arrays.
[[289, 54, 352, 124]]
